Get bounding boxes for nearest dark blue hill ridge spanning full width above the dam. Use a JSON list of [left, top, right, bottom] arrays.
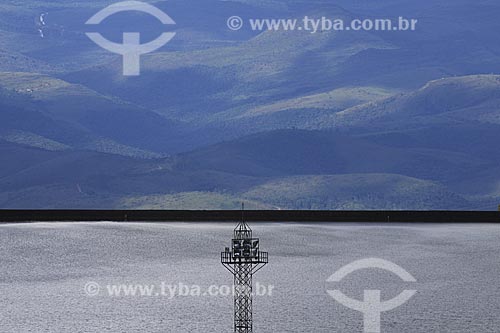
[[0, 124, 499, 209]]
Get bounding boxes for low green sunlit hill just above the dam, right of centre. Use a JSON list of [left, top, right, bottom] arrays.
[[243, 174, 470, 210]]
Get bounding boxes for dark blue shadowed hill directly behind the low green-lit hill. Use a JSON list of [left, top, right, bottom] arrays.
[[175, 130, 488, 182]]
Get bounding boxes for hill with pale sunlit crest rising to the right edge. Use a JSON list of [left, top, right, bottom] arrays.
[[316, 75, 500, 127]]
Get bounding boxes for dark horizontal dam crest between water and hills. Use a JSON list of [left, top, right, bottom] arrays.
[[0, 209, 500, 223]]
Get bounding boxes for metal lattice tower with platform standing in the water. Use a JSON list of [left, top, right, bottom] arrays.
[[221, 204, 268, 333]]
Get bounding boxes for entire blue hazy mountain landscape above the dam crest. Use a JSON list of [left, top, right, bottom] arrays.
[[0, 0, 500, 210]]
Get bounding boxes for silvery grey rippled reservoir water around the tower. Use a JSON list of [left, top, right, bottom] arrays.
[[0, 223, 500, 333]]
